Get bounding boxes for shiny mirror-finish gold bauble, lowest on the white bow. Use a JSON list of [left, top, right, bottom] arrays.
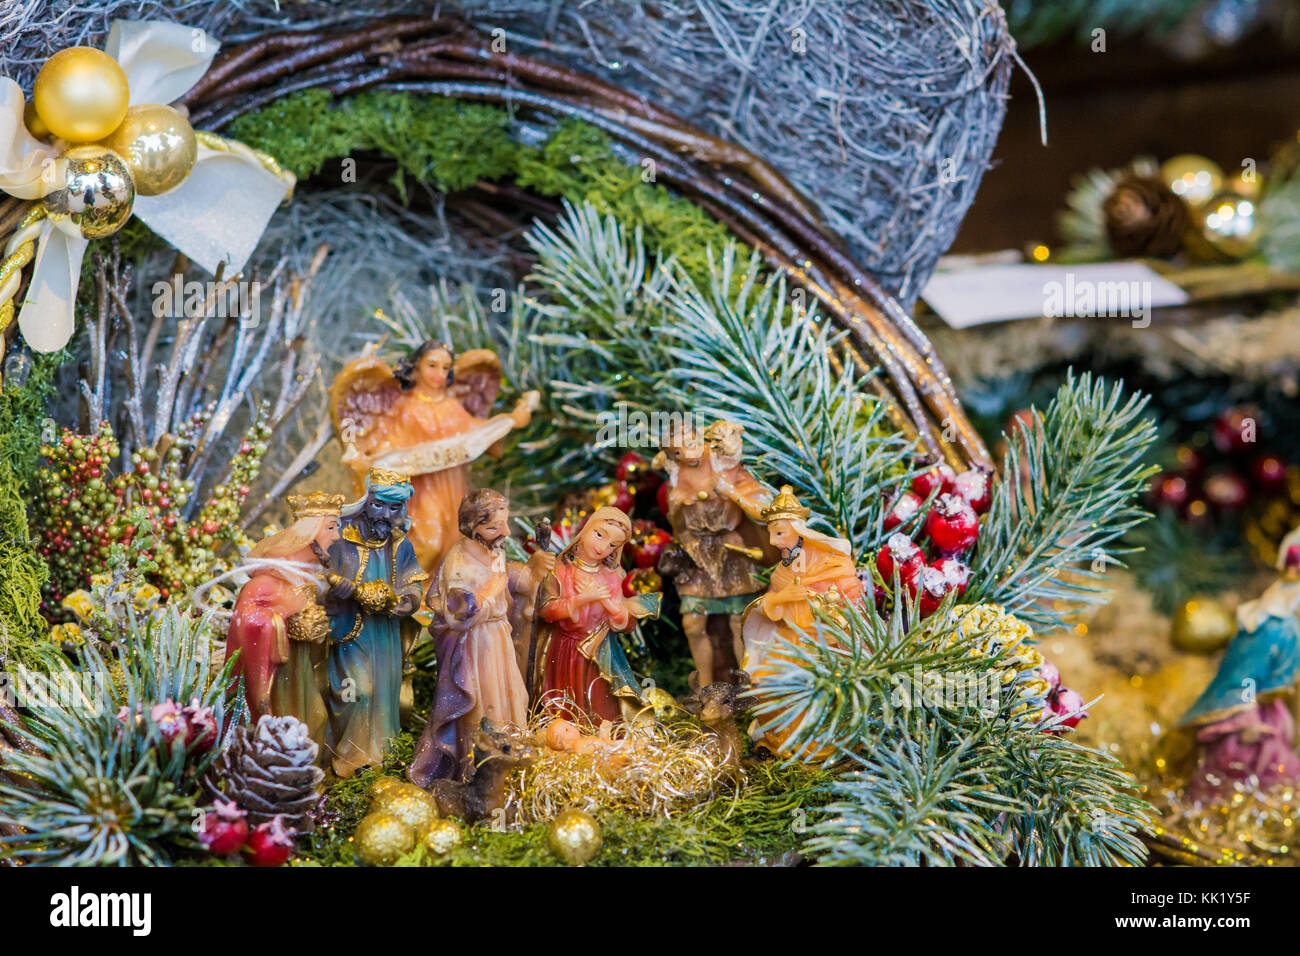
[[42, 146, 135, 239]]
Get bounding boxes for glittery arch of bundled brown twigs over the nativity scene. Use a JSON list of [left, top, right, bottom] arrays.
[[178, 18, 993, 467]]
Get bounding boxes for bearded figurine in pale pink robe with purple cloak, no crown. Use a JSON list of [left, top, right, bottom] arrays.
[[410, 488, 555, 787]]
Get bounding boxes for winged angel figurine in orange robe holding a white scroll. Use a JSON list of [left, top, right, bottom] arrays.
[[330, 341, 538, 572]]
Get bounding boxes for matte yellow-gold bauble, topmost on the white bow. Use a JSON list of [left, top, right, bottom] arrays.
[[31, 47, 130, 143]]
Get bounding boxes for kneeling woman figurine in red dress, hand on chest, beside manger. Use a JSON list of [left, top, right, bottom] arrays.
[[529, 507, 663, 727]]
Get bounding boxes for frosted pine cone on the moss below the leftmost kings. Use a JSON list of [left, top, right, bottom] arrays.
[[208, 714, 325, 834]]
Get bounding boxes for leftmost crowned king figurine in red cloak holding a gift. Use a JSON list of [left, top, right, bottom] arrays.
[[226, 492, 343, 749]]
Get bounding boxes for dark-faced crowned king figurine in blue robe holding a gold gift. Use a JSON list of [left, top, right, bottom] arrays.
[[325, 468, 428, 777]]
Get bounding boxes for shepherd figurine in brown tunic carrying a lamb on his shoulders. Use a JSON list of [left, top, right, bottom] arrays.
[[654, 419, 776, 688]]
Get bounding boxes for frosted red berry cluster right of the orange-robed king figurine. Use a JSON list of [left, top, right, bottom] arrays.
[[875, 464, 992, 617]]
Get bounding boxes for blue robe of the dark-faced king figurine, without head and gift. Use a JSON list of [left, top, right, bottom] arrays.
[[325, 522, 428, 777]]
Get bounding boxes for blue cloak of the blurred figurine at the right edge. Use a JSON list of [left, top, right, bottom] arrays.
[[1179, 614, 1300, 727]]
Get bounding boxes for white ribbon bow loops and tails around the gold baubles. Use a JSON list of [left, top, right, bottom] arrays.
[[0, 20, 294, 352]]
